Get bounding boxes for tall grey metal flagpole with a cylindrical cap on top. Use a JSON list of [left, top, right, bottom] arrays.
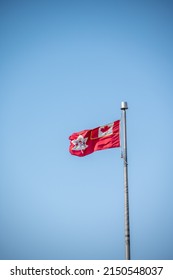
[[121, 102, 130, 260]]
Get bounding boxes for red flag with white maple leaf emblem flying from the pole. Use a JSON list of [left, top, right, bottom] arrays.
[[69, 120, 120, 157]]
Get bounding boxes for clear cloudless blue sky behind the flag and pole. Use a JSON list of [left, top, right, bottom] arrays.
[[0, 0, 173, 260]]
